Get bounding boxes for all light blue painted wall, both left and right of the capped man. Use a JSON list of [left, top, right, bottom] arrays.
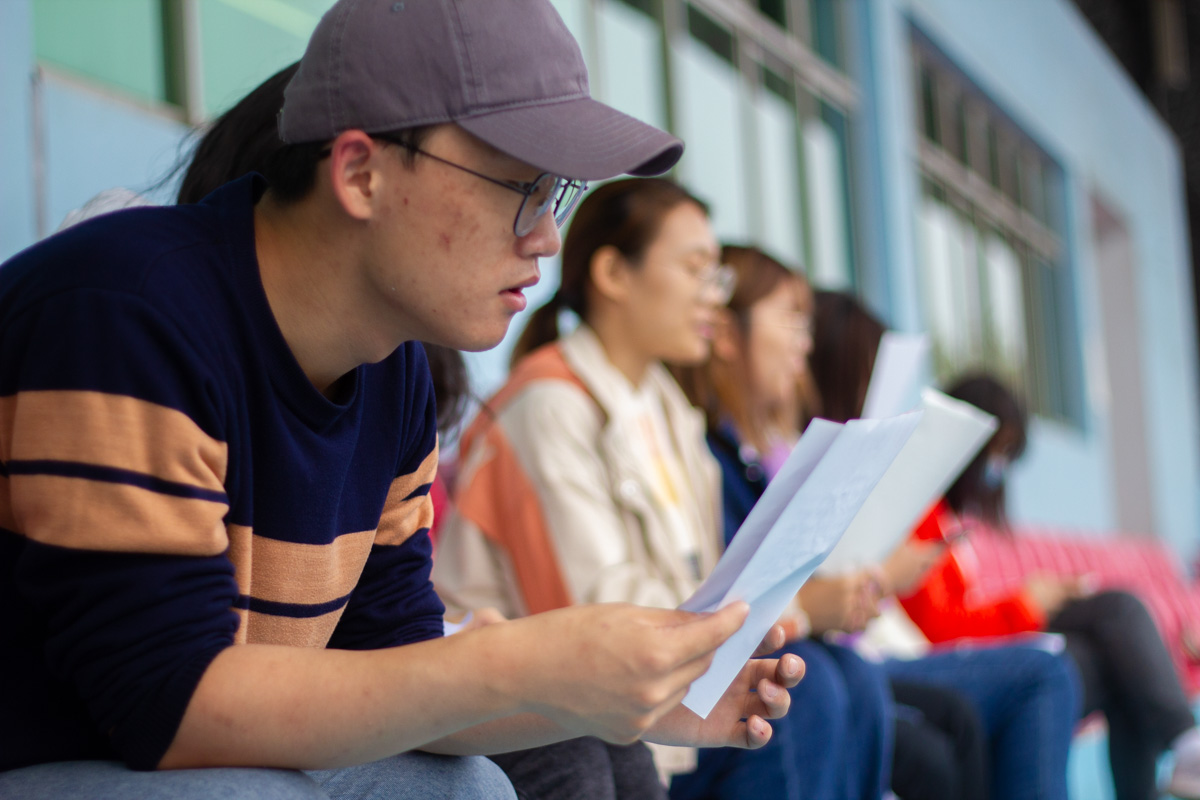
[[7, 0, 1200, 559]]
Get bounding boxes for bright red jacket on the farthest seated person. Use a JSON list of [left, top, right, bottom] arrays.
[[900, 500, 1045, 643]]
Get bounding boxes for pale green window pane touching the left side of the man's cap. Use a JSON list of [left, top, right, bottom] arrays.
[[199, 0, 334, 115]]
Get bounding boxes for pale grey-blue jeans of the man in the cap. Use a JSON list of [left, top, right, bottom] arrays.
[[0, 752, 516, 800]]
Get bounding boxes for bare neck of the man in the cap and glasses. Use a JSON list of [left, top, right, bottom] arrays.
[[254, 192, 381, 397]]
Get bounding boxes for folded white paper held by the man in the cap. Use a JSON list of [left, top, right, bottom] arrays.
[[680, 411, 922, 717]]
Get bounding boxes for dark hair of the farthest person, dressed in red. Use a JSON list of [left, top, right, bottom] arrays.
[[946, 373, 1028, 531]]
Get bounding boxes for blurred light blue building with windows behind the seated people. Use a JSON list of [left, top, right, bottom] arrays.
[[0, 0, 1200, 561]]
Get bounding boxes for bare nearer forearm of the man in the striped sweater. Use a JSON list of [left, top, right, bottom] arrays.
[[160, 630, 537, 769]]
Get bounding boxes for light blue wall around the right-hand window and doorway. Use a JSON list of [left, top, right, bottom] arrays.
[[854, 0, 1200, 559]]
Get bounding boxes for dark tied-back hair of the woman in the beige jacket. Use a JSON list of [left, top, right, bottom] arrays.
[[509, 178, 708, 366]]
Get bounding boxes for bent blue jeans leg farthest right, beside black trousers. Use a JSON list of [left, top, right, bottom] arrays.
[[883, 646, 1080, 800]]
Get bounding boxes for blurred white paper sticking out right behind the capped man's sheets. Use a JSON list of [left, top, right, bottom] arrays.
[[821, 389, 996, 573]]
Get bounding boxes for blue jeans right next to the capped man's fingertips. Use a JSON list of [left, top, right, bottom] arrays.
[[670, 639, 893, 800]]
